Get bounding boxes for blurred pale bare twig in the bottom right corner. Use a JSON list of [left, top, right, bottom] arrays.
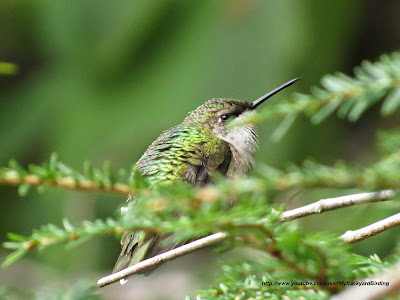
[[330, 262, 400, 300]]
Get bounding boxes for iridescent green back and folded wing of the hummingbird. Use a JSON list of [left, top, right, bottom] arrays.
[[136, 123, 231, 186]]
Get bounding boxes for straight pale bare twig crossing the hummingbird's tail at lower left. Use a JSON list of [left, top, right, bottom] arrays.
[[97, 232, 228, 287]]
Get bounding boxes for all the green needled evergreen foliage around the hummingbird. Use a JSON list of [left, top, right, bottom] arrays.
[[0, 53, 400, 299]]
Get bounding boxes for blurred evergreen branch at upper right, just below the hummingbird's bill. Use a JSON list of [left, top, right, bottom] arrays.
[[236, 52, 400, 139]]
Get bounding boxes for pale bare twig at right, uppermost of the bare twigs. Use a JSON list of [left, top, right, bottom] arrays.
[[280, 190, 396, 222]]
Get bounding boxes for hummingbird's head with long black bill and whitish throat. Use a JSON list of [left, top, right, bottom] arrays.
[[184, 78, 300, 161]]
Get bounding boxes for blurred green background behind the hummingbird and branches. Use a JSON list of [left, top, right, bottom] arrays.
[[0, 0, 400, 299]]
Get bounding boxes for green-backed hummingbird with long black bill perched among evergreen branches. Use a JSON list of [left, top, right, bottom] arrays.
[[113, 77, 300, 278]]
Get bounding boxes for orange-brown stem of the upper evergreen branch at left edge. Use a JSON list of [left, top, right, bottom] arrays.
[[0, 171, 133, 195]]
